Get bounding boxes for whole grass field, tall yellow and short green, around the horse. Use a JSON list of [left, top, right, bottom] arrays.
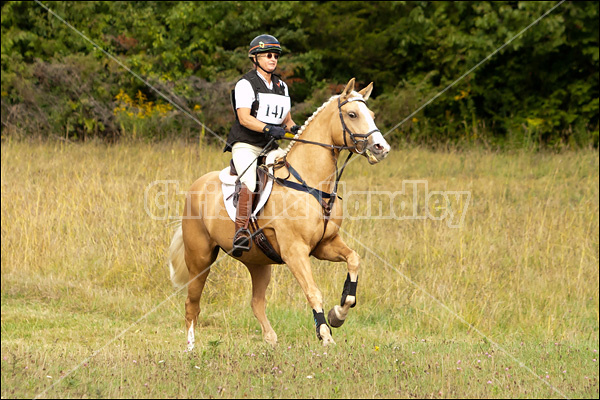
[[1, 139, 599, 398]]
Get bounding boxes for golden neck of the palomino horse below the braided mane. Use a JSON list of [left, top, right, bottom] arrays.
[[287, 110, 339, 191]]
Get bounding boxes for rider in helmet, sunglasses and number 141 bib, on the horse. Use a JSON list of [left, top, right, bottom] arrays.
[[225, 35, 298, 257]]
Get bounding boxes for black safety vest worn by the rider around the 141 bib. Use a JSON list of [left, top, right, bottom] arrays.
[[223, 70, 285, 151]]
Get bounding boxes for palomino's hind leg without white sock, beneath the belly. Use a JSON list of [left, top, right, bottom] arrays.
[[246, 264, 277, 346]]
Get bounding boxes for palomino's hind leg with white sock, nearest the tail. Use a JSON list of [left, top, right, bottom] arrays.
[[185, 246, 219, 350]]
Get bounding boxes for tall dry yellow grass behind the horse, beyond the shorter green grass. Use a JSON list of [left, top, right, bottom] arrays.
[[2, 141, 598, 337]]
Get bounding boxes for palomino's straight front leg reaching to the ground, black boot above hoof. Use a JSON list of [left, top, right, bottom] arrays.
[[282, 244, 335, 346]]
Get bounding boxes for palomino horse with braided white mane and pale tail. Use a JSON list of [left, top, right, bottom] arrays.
[[169, 78, 390, 350]]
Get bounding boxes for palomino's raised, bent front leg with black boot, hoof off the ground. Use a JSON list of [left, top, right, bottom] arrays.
[[313, 235, 360, 328]]
